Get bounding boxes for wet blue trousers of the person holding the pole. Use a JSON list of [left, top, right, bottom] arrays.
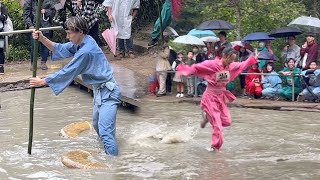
[[92, 83, 121, 156]]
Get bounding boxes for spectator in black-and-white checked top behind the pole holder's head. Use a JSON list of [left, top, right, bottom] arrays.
[[72, 0, 102, 46]]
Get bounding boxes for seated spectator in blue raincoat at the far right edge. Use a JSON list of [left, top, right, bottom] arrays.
[[297, 62, 320, 101]]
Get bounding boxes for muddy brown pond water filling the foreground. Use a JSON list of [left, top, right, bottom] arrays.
[[0, 87, 320, 180]]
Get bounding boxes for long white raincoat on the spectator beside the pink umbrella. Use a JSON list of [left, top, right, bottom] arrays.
[[102, 0, 140, 39]]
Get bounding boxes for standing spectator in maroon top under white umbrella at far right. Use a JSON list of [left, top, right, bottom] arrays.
[[295, 33, 318, 70]]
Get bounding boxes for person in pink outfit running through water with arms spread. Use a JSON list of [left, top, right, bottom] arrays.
[[177, 47, 257, 150]]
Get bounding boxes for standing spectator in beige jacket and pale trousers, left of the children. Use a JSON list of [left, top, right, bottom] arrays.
[[156, 46, 171, 97]]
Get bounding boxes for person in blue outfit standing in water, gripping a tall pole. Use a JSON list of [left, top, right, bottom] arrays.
[[30, 17, 121, 156]]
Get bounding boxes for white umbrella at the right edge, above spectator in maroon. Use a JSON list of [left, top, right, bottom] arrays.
[[288, 16, 320, 33]]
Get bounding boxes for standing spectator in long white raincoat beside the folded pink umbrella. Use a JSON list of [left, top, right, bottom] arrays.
[[103, 0, 140, 59]]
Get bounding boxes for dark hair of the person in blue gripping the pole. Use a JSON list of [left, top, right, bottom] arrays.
[[64, 16, 89, 34]]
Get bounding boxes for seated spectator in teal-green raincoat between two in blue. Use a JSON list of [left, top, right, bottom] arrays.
[[279, 58, 301, 100]]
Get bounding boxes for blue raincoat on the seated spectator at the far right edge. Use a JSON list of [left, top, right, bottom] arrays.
[[301, 69, 320, 99]]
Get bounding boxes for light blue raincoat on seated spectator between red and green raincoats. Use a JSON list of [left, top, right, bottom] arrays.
[[262, 71, 282, 97]]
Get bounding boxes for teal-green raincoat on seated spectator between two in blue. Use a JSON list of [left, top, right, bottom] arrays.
[[278, 67, 301, 100]]
